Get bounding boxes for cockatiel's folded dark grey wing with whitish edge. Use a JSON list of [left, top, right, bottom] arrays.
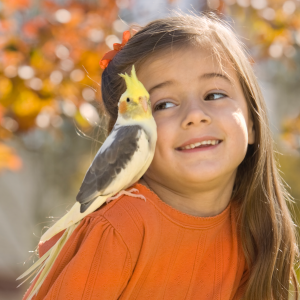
[[76, 125, 149, 213]]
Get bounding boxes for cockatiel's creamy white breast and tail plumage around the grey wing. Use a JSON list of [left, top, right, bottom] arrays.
[[18, 91, 157, 300]]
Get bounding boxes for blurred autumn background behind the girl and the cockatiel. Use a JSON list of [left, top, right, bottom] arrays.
[[0, 0, 300, 300]]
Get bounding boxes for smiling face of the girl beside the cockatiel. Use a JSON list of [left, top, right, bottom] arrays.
[[137, 48, 255, 191]]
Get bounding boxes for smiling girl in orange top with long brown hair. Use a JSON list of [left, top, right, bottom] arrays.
[[24, 14, 298, 300]]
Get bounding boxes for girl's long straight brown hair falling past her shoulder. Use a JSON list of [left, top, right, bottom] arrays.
[[101, 13, 299, 300]]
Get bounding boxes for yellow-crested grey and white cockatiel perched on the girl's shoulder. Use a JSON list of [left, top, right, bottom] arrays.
[[17, 66, 157, 300]]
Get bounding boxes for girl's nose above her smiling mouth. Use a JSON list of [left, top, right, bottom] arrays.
[[181, 99, 211, 129]]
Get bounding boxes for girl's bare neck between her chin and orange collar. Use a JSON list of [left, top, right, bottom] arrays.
[[140, 174, 235, 217]]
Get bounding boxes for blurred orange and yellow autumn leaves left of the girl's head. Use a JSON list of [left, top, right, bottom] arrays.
[[0, 0, 122, 171]]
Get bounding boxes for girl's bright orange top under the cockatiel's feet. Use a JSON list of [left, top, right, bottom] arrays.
[[23, 184, 248, 300]]
